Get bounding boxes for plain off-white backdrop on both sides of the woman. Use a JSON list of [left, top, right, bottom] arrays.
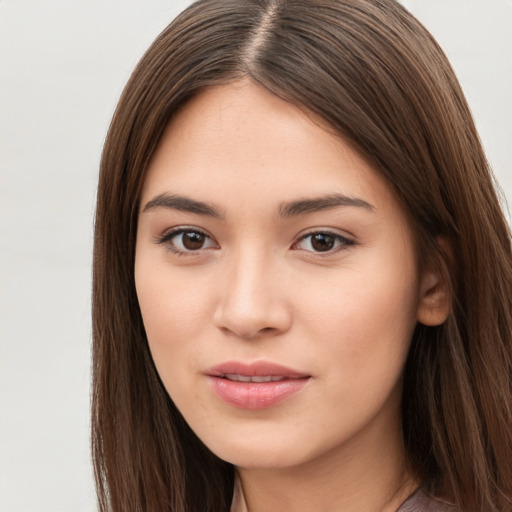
[[0, 0, 512, 512]]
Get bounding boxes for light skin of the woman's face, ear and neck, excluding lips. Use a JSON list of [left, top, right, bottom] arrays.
[[135, 80, 447, 512]]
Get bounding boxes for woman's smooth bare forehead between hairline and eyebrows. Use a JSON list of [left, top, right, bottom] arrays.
[[143, 80, 396, 219]]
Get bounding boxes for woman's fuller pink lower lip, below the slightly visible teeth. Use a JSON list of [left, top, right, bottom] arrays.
[[209, 376, 309, 409]]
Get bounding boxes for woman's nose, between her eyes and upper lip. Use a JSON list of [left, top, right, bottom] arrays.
[[213, 249, 292, 339]]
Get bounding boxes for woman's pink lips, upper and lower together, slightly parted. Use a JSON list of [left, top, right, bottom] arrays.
[[206, 361, 311, 409]]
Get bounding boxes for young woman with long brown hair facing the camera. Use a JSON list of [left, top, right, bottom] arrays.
[[92, 0, 512, 512]]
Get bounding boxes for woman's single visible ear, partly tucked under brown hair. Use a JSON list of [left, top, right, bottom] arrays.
[[417, 239, 451, 326]]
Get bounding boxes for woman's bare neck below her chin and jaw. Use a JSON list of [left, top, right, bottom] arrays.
[[237, 400, 418, 512]]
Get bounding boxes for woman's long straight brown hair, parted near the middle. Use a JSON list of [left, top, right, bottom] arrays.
[[92, 0, 512, 512]]
